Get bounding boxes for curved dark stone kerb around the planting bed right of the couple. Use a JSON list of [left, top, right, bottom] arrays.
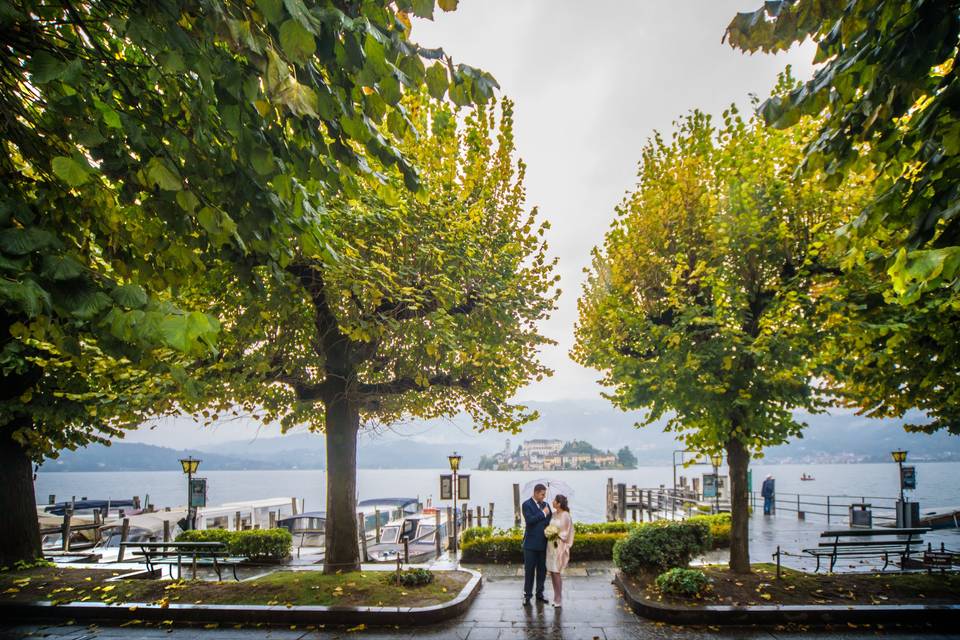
[[613, 572, 960, 626]]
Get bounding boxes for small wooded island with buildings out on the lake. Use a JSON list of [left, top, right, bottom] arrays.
[[477, 438, 637, 471]]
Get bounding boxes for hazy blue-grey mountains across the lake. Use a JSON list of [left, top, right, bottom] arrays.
[[43, 400, 960, 471]]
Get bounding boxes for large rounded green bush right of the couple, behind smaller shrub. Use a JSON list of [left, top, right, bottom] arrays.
[[613, 521, 710, 575]]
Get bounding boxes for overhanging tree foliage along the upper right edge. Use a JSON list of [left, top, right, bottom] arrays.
[[727, 0, 960, 433]]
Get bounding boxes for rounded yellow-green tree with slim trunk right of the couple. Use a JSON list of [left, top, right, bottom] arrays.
[[573, 92, 868, 572]]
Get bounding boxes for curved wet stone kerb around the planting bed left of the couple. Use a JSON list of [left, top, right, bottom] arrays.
[[0, 568, 483, 626]]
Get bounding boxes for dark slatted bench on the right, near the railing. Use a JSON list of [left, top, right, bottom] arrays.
[[803, 529, 929, 571]]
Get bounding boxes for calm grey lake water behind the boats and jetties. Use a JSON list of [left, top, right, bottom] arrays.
[[35, 462, 960, 527]]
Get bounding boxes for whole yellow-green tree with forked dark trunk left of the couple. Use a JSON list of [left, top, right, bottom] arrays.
[[195, 98, 557, 571]]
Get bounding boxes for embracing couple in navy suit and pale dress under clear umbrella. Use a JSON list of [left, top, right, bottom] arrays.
[[521, 480, 573, 608]]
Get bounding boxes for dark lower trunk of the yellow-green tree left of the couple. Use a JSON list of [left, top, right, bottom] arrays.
[[323, 393, 360, 573]]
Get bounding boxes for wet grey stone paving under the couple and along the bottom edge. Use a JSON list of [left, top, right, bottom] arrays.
[[0, 563, 955, 640]]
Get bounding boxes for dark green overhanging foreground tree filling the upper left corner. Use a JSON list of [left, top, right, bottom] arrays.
[[0, 0, 495, 563]]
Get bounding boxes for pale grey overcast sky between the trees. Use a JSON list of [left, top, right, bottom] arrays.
[[126, 0, 813, 446]]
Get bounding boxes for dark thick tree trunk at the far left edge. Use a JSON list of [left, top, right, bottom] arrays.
[[0, 425, 43, 567]]
